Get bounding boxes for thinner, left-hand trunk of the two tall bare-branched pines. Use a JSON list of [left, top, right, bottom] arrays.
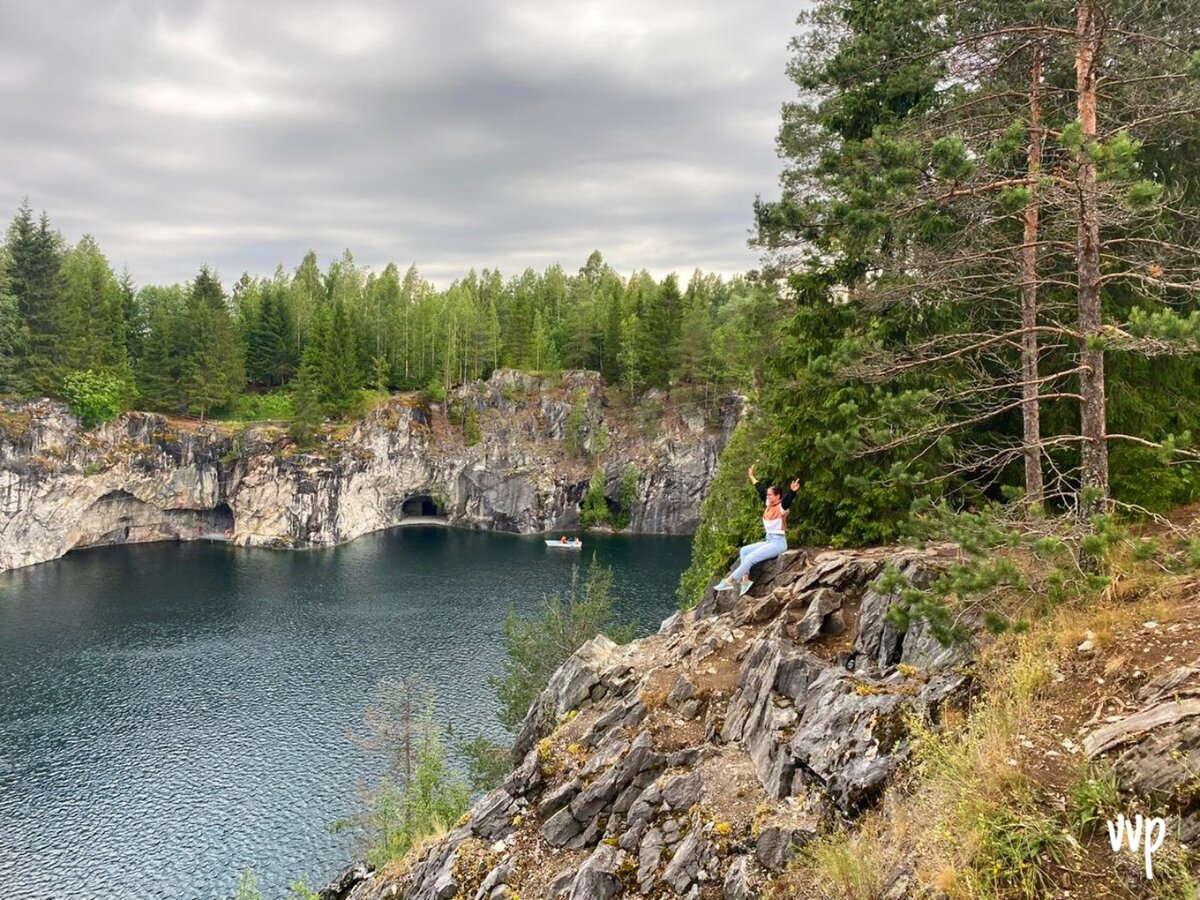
[[1021, 43, 1045, 504]]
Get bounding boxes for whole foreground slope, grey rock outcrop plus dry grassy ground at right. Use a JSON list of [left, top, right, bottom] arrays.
[[320, 545, 1200, 900]]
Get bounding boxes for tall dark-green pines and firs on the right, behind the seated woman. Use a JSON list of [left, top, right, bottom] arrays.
[[683, 0, 1200, 600]]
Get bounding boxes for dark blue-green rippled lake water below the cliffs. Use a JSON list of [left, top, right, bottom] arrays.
[[0, 528, 689, 900]]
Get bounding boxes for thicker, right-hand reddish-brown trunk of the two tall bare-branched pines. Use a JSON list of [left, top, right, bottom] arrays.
[[1075, 0, 1109, 512]]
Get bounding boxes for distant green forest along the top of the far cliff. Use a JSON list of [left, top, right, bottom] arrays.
[[0, 202, 779, 427]]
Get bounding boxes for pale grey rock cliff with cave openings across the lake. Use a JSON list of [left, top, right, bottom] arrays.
[[0, 370, 740, 571]]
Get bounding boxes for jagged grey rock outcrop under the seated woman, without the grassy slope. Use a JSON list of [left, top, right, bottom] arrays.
[[333, 547, 971, 900]]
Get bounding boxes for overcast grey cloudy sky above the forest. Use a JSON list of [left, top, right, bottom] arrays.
[[0, 0, 799, 284]]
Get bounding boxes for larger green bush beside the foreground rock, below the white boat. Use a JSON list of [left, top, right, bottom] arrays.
[[488, 560, 634, 730]]
